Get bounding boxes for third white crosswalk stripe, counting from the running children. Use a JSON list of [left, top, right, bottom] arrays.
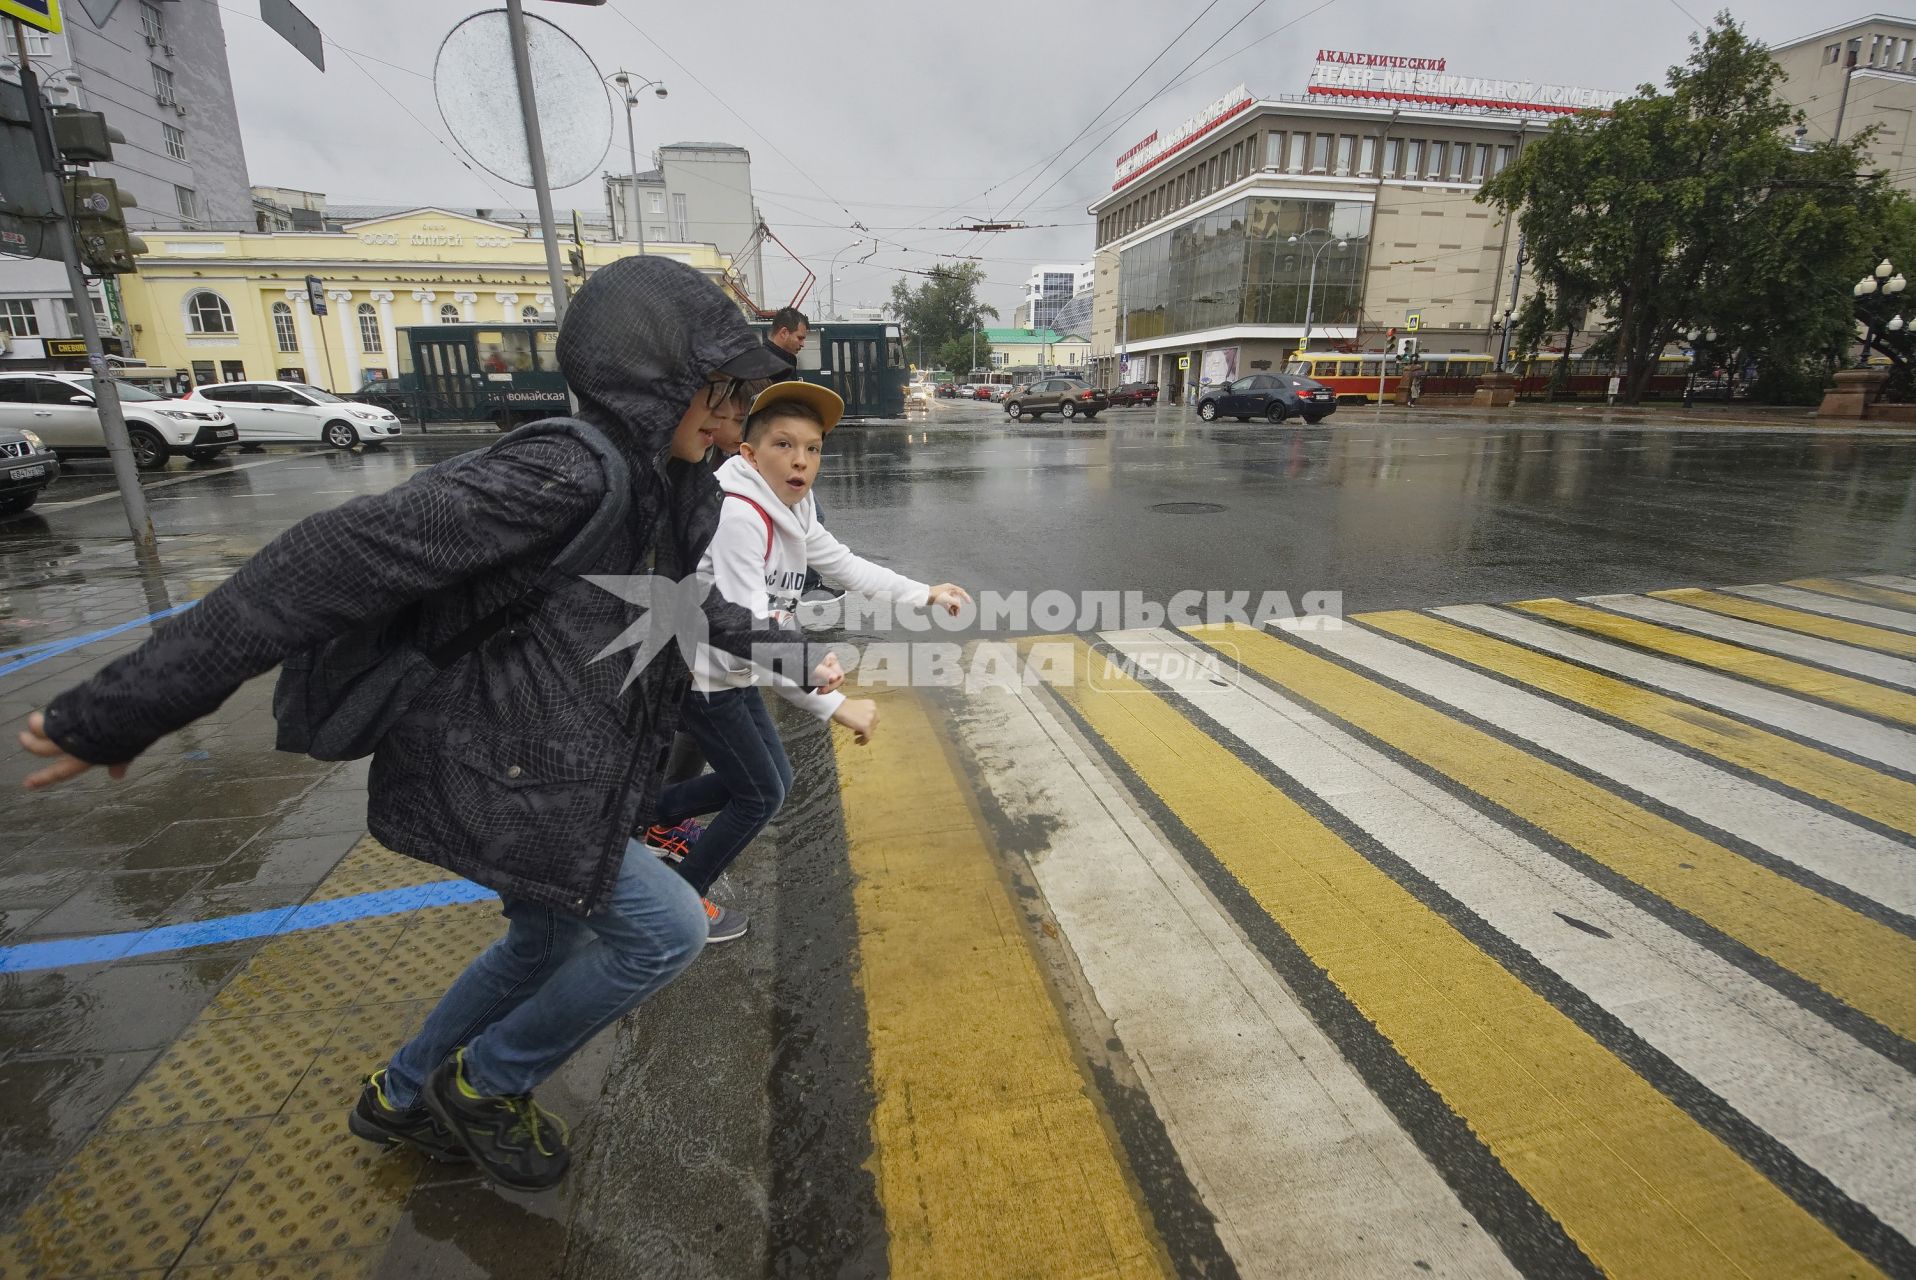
[[1286, 627, 1916, 916]]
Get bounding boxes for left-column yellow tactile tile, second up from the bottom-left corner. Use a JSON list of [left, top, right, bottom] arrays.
[[102, 1010, 345, 1132]]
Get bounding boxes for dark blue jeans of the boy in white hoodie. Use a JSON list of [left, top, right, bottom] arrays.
[[653, 688, 791, 893]]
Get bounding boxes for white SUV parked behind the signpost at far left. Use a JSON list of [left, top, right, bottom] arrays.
[[0, 372, 240, 471]]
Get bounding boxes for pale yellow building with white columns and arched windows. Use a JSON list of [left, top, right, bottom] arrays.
[[121, 209, 732, 391]]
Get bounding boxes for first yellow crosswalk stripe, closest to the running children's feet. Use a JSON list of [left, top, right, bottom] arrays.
[[833, 696, 1169, 1280]]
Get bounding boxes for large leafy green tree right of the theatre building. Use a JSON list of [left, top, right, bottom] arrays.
[[1477, 13, 1887, 404]]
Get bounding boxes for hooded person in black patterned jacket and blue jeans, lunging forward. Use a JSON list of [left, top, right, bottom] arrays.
[[21, 259, 841, 1190]]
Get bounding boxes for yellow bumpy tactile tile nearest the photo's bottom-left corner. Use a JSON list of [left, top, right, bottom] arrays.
[[0, 1121, 268, 1280]]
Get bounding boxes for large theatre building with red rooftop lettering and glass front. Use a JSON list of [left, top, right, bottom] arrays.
[[1090, 50, 1615, 393]]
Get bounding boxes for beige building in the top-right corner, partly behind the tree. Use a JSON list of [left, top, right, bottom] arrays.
[[1770, 13, 1916, 194]]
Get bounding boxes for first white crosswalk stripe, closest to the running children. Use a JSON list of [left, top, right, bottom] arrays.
[[958, 674, 1516, 1276]]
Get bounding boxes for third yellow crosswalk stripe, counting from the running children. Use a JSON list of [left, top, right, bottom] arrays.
[[1192, 627, 1916, 1039]]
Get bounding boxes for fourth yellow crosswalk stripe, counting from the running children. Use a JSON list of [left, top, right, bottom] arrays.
[[1357, 609, 1916, 835]]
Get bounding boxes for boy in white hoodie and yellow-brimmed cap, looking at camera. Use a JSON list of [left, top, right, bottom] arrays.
[[655, 381, 971, 943]]
